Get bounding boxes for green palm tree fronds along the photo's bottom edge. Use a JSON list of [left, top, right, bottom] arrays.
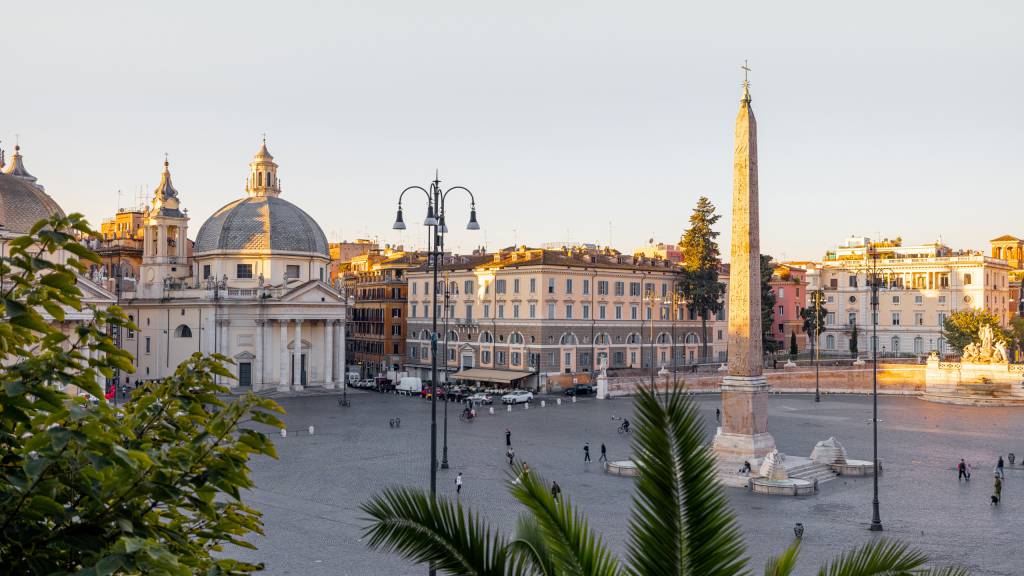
[[361, 388, 968, 576]]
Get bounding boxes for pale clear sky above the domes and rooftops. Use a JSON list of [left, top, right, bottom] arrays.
[[0, 0, 1024, 259]]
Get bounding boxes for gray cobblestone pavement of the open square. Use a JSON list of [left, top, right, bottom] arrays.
[[238, 392, 1024, 576]]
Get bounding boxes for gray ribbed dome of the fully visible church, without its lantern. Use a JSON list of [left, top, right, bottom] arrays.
[[193, 196, 331, 258]]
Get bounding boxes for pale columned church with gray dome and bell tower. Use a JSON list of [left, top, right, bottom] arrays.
[[121, 141, 347, 392]]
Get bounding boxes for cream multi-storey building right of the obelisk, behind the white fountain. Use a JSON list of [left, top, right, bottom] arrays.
[[818, 238, 1011, 356]]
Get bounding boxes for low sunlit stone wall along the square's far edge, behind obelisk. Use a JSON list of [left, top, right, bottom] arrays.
[[608, 363, 925, 397]]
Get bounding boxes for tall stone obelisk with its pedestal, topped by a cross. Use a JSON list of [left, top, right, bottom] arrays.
[[714, 66, 775, 484]]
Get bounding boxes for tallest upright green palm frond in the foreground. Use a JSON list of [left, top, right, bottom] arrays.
[[628, 388, 746, 576]]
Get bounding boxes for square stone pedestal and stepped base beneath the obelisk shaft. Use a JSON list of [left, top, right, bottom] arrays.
[[712, 376, 775, 487]]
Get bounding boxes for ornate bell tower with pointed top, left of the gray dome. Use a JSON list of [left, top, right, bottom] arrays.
[[140, 157, 189, 292]]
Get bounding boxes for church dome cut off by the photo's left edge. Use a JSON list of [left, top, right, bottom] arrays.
[[0, 147, 65, 234]]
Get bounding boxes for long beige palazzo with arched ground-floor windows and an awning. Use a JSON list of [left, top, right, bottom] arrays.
[[406, 247, 726, 389]]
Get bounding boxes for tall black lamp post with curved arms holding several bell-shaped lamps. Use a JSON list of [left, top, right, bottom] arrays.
[[391, 174, 480, 557]]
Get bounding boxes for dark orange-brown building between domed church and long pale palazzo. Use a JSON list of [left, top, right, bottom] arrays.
[[341, 247, 426, 378]]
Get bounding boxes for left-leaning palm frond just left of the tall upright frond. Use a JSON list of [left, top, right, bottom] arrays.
[[509, 466, 621, 576]]
